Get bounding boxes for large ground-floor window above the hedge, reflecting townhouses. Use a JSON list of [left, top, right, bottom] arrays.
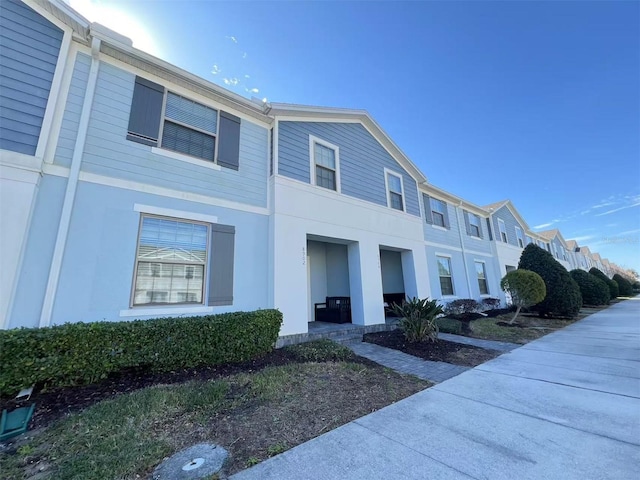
[[131, 214, 210, 307]]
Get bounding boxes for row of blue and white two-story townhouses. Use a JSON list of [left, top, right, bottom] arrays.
[[0, 0, 632, 335]]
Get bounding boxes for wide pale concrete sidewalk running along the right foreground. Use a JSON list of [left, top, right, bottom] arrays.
[[232, 298, 640, 480]]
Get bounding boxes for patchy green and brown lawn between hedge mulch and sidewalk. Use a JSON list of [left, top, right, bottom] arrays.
[[0, 344, 430, 480]]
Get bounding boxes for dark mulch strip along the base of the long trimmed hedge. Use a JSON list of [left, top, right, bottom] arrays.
[[0, 349, 371, 429]]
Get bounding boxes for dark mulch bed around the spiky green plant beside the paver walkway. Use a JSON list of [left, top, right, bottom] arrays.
[[364, 330, 502, 367]]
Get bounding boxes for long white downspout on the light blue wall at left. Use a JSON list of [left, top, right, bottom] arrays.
[[40, 37, 100, 327]]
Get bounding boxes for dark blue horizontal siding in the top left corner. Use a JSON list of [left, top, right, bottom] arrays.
[[0, 0, 64, 155]]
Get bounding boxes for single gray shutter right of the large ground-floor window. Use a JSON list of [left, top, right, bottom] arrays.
[[207, 223, 236, 305]]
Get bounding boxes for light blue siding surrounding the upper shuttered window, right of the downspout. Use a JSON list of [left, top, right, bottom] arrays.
[[77, 63, 268, 207]]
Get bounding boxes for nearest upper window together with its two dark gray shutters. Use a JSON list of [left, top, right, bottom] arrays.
[[127, 77, 240, 170]]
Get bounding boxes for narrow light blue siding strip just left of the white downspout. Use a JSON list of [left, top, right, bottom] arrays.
[[54, 53, 91, 167]]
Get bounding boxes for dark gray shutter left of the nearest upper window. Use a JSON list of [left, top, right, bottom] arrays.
[[127, 77, 164, 146]]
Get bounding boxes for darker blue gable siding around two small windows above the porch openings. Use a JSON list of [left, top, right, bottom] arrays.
[[278, 121, 420, 216]]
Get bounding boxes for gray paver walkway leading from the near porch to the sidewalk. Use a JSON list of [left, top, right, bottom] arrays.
[[347, 342, 469, 382]]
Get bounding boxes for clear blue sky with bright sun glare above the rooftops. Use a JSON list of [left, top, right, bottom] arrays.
[[69, 0, 640, 271]]
